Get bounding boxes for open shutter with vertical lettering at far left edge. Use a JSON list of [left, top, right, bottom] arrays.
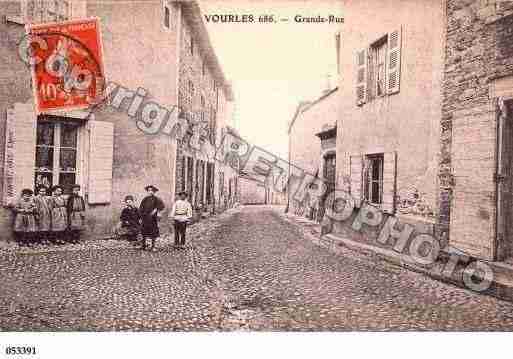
[[3, 103, 37, 205]]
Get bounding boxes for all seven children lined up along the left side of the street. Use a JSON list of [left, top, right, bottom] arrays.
[[12, 184, 192, 250]]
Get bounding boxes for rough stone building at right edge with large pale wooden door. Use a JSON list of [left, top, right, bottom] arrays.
[[439, 0, 513, 260]]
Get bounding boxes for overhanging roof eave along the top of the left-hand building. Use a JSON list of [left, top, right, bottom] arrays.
[[180, 1, 233, 101]]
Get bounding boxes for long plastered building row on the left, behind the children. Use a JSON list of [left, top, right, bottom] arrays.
[[0, 0, 236, 242]]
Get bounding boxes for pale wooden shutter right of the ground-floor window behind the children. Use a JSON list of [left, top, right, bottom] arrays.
[[88, 121, 114, 204]]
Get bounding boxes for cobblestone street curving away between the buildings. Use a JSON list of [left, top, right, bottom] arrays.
[[0, 206, 513, 331]]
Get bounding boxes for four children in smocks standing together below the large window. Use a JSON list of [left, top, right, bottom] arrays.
[[12, 184, 86, 246]]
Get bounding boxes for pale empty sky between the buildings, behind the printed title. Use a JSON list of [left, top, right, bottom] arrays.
[[200, 0, 343, 158]]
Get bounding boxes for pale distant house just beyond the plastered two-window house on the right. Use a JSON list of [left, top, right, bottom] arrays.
[[287, 88, 340, 220]]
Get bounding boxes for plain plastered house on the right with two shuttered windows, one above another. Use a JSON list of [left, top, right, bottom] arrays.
[[335, 0, 445, 238]]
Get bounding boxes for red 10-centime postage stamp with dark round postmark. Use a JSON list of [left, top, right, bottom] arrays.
[[26, 18, 105, 113]]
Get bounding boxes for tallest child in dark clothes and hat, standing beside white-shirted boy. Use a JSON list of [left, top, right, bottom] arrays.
[[139, 185, 166, 250]]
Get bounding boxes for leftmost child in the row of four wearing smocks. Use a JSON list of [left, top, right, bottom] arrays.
[[14, 188, 37, 246]]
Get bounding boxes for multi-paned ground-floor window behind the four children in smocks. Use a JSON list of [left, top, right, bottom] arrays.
[[34, 121, 78, 193]]
